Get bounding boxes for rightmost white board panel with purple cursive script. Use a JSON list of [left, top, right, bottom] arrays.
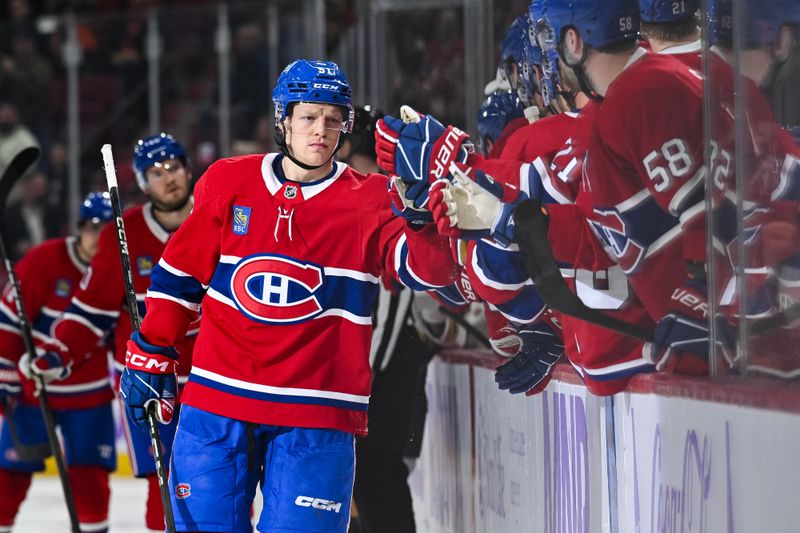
[[615, 393, 800, 533]]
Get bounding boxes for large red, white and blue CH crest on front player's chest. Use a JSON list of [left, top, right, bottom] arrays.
[[231, 255, 322, 324]]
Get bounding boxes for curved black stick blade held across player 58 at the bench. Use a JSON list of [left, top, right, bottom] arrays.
[[514, 200, 653, 342]]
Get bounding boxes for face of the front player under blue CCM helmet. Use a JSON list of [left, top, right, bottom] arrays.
[[285, 103, 344, 165]]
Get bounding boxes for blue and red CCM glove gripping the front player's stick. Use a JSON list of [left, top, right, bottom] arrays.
[[119, 331, 178, 431]]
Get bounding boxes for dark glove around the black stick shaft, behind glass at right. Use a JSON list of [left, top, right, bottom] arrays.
[[642, 279, 735, 376]]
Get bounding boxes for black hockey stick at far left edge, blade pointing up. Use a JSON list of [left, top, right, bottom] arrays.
[[0, 146, 81, 533]]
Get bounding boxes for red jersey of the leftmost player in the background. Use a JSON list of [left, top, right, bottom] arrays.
[[0, 237, 113, 409]]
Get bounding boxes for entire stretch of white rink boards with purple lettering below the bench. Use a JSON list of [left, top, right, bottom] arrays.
[[410, 359, 800, 533]]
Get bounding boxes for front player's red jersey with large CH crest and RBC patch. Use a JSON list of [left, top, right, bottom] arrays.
[[142, 154, 455, 434]]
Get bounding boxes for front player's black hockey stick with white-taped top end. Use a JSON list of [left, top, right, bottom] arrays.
[[100, 144, 175, 533]]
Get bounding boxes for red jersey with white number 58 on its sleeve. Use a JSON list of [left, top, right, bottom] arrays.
[[550, 49, 705, 320]]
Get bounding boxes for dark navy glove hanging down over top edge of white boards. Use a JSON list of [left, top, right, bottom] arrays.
[[490, 322, 564, 395]]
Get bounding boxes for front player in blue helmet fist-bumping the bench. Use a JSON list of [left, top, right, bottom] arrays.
[[116, 59, 453, 532]]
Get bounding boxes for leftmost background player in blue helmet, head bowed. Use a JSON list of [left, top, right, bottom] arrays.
[[0, 192, 116, 533]]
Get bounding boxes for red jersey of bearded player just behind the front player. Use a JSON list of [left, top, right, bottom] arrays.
[[54, 203, 198, 381]]
